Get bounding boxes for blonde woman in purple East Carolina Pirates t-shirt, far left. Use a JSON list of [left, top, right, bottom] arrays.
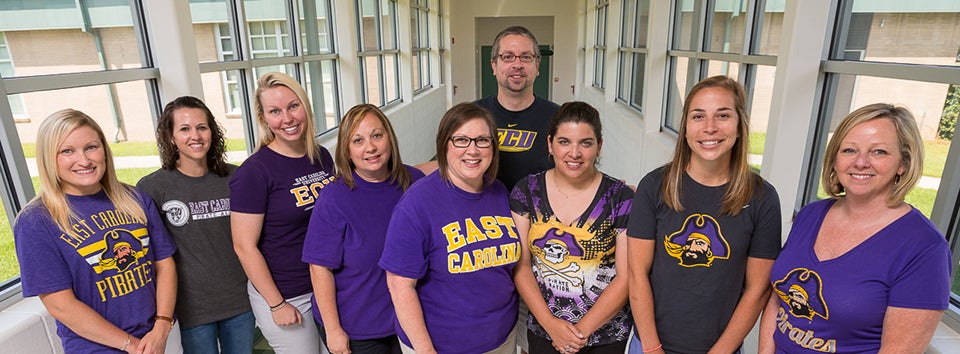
[[14, 109, 179, 353]]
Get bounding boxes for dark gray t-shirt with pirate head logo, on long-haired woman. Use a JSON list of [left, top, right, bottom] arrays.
[[627, 167, 780, 353]]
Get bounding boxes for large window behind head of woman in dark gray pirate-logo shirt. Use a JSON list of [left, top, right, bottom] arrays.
[[663, 0, 783, 170]]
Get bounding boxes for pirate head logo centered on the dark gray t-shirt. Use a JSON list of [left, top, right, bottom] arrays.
[[663, 214, 730, 267]]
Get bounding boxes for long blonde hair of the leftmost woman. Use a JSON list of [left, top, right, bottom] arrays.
[[25, 109, 147, 240]]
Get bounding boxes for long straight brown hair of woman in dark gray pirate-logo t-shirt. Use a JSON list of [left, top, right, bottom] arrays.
[[661, 75, 763, 215]]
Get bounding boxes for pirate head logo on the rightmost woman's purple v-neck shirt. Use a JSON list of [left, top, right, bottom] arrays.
[[773, 268, 830, 320]]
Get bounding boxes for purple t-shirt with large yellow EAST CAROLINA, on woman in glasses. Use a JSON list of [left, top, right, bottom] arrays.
[[380, 172, 520, 353]]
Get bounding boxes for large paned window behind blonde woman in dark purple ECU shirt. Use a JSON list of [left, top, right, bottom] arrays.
[[190, 0, 340, 137]]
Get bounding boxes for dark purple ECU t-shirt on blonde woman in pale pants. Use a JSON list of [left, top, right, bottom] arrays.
[[230, 146, 333, 299]]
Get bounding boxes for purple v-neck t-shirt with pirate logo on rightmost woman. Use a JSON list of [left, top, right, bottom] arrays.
[[770, 199, 952, 353]]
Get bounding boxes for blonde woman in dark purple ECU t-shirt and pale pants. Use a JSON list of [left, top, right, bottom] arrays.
[[230, 72, 334, 353]]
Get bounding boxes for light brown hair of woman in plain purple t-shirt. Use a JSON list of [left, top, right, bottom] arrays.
[[334, 103, 413, 190]]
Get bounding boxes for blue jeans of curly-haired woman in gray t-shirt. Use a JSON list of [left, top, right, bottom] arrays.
[[180, 311, 256, 354]]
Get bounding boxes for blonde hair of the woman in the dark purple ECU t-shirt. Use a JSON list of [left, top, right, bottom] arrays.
[[253, 72, 322, 164]]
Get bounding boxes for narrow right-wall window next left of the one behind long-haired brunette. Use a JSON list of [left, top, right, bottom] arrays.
[[617, 0, 650, 109]]
